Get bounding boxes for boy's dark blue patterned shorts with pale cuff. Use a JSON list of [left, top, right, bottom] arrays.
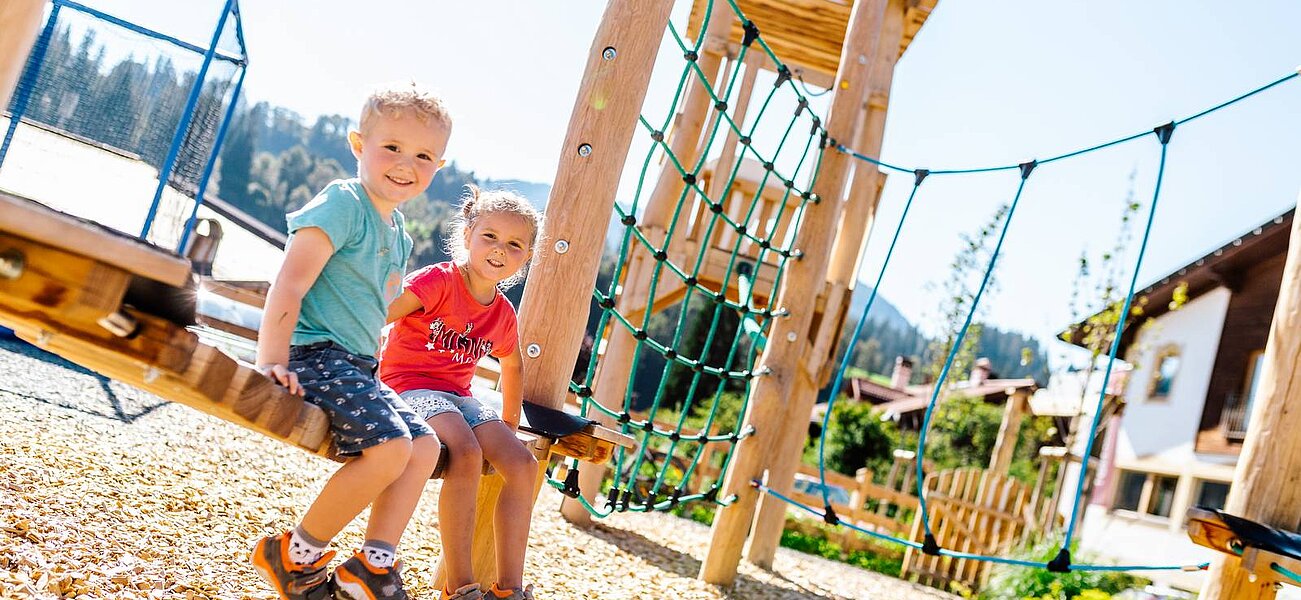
[[289, 341, 433, 457]]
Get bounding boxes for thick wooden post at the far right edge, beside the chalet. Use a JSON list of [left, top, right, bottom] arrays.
[[1200, 191, 1301, 600]]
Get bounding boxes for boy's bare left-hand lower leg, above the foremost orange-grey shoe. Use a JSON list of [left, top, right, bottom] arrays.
[[301, 437, 411, 540]]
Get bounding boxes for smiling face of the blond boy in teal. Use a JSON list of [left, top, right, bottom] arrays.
[[347, 111, 451, 207]]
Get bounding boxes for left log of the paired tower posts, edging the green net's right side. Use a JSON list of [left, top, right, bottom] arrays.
[[700, 0, 886, 586]]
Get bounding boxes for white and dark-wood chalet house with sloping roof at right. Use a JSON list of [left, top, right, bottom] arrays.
[[1063, 210, 1294, 590]]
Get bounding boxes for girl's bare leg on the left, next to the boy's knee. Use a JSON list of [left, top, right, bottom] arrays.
[[428, 413, 484, 590]]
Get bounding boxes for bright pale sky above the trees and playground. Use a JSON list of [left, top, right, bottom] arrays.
[[90, 0, 1301, 367]]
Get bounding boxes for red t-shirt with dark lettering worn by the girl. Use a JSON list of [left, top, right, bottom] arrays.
[[380, 262, 519, 396]]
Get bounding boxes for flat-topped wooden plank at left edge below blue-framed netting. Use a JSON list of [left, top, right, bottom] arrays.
[[0, 190, 191, 288]]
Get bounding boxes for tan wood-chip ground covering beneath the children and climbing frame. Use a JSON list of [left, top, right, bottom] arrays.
[[0, 338, 954, 600]]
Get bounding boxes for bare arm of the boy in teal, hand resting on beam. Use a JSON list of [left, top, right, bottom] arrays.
[[258, 226, 334, 396]]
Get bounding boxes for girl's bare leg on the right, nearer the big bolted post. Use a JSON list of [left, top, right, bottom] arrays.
[[475, 420, 537, 590]]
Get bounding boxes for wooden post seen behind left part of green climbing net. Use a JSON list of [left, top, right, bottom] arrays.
[[561, 3, 731, 525]]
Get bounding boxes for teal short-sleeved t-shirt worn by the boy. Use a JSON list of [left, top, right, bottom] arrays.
[[286, 178, 411, 357]]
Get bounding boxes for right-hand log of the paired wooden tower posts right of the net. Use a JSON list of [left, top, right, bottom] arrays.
[[745, 0, 905, 569]]
